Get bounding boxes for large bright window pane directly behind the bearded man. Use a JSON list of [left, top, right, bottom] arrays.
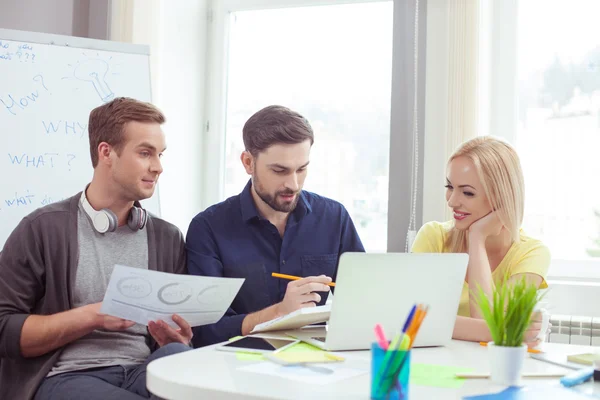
[[223, 1, 393, 251]]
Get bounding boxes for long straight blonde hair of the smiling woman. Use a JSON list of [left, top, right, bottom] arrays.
[[446, 136, 525, 253]]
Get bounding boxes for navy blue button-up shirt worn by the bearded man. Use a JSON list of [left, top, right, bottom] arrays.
[[186, 181, 365, 347]]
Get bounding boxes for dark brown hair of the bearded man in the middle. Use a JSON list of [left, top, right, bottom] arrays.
[[242, 106, 315, 157]]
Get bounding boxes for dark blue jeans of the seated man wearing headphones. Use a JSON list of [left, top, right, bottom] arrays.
[[35, 343, 191, 400]]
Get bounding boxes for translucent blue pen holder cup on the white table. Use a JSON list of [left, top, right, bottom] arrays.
[[371, 343, 410, 400]]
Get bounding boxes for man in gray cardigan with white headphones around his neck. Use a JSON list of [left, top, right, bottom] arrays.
[[0, 98, 192, 400]]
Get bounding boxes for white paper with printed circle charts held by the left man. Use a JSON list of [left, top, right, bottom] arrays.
[[100, 265, 244, 328]]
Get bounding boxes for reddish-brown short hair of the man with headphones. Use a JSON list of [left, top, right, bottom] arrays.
[[88, 97, 165, 168]]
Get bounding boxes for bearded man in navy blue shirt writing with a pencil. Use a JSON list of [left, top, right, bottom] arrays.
[[186, 106, 364, 347]]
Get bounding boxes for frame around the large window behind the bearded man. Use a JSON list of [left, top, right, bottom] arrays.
[[201, 0, 426, 251]]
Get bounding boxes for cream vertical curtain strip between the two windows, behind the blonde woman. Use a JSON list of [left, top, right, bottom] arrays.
[[423, 0, 481, 222]]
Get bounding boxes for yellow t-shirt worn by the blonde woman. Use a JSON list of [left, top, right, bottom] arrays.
[[411, 221, 550, 317]]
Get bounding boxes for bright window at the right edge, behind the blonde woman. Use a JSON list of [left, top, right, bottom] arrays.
[[516, 0, 600, 268]]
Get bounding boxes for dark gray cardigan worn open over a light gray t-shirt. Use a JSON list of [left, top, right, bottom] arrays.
[[0, 193, 187, 400]]
